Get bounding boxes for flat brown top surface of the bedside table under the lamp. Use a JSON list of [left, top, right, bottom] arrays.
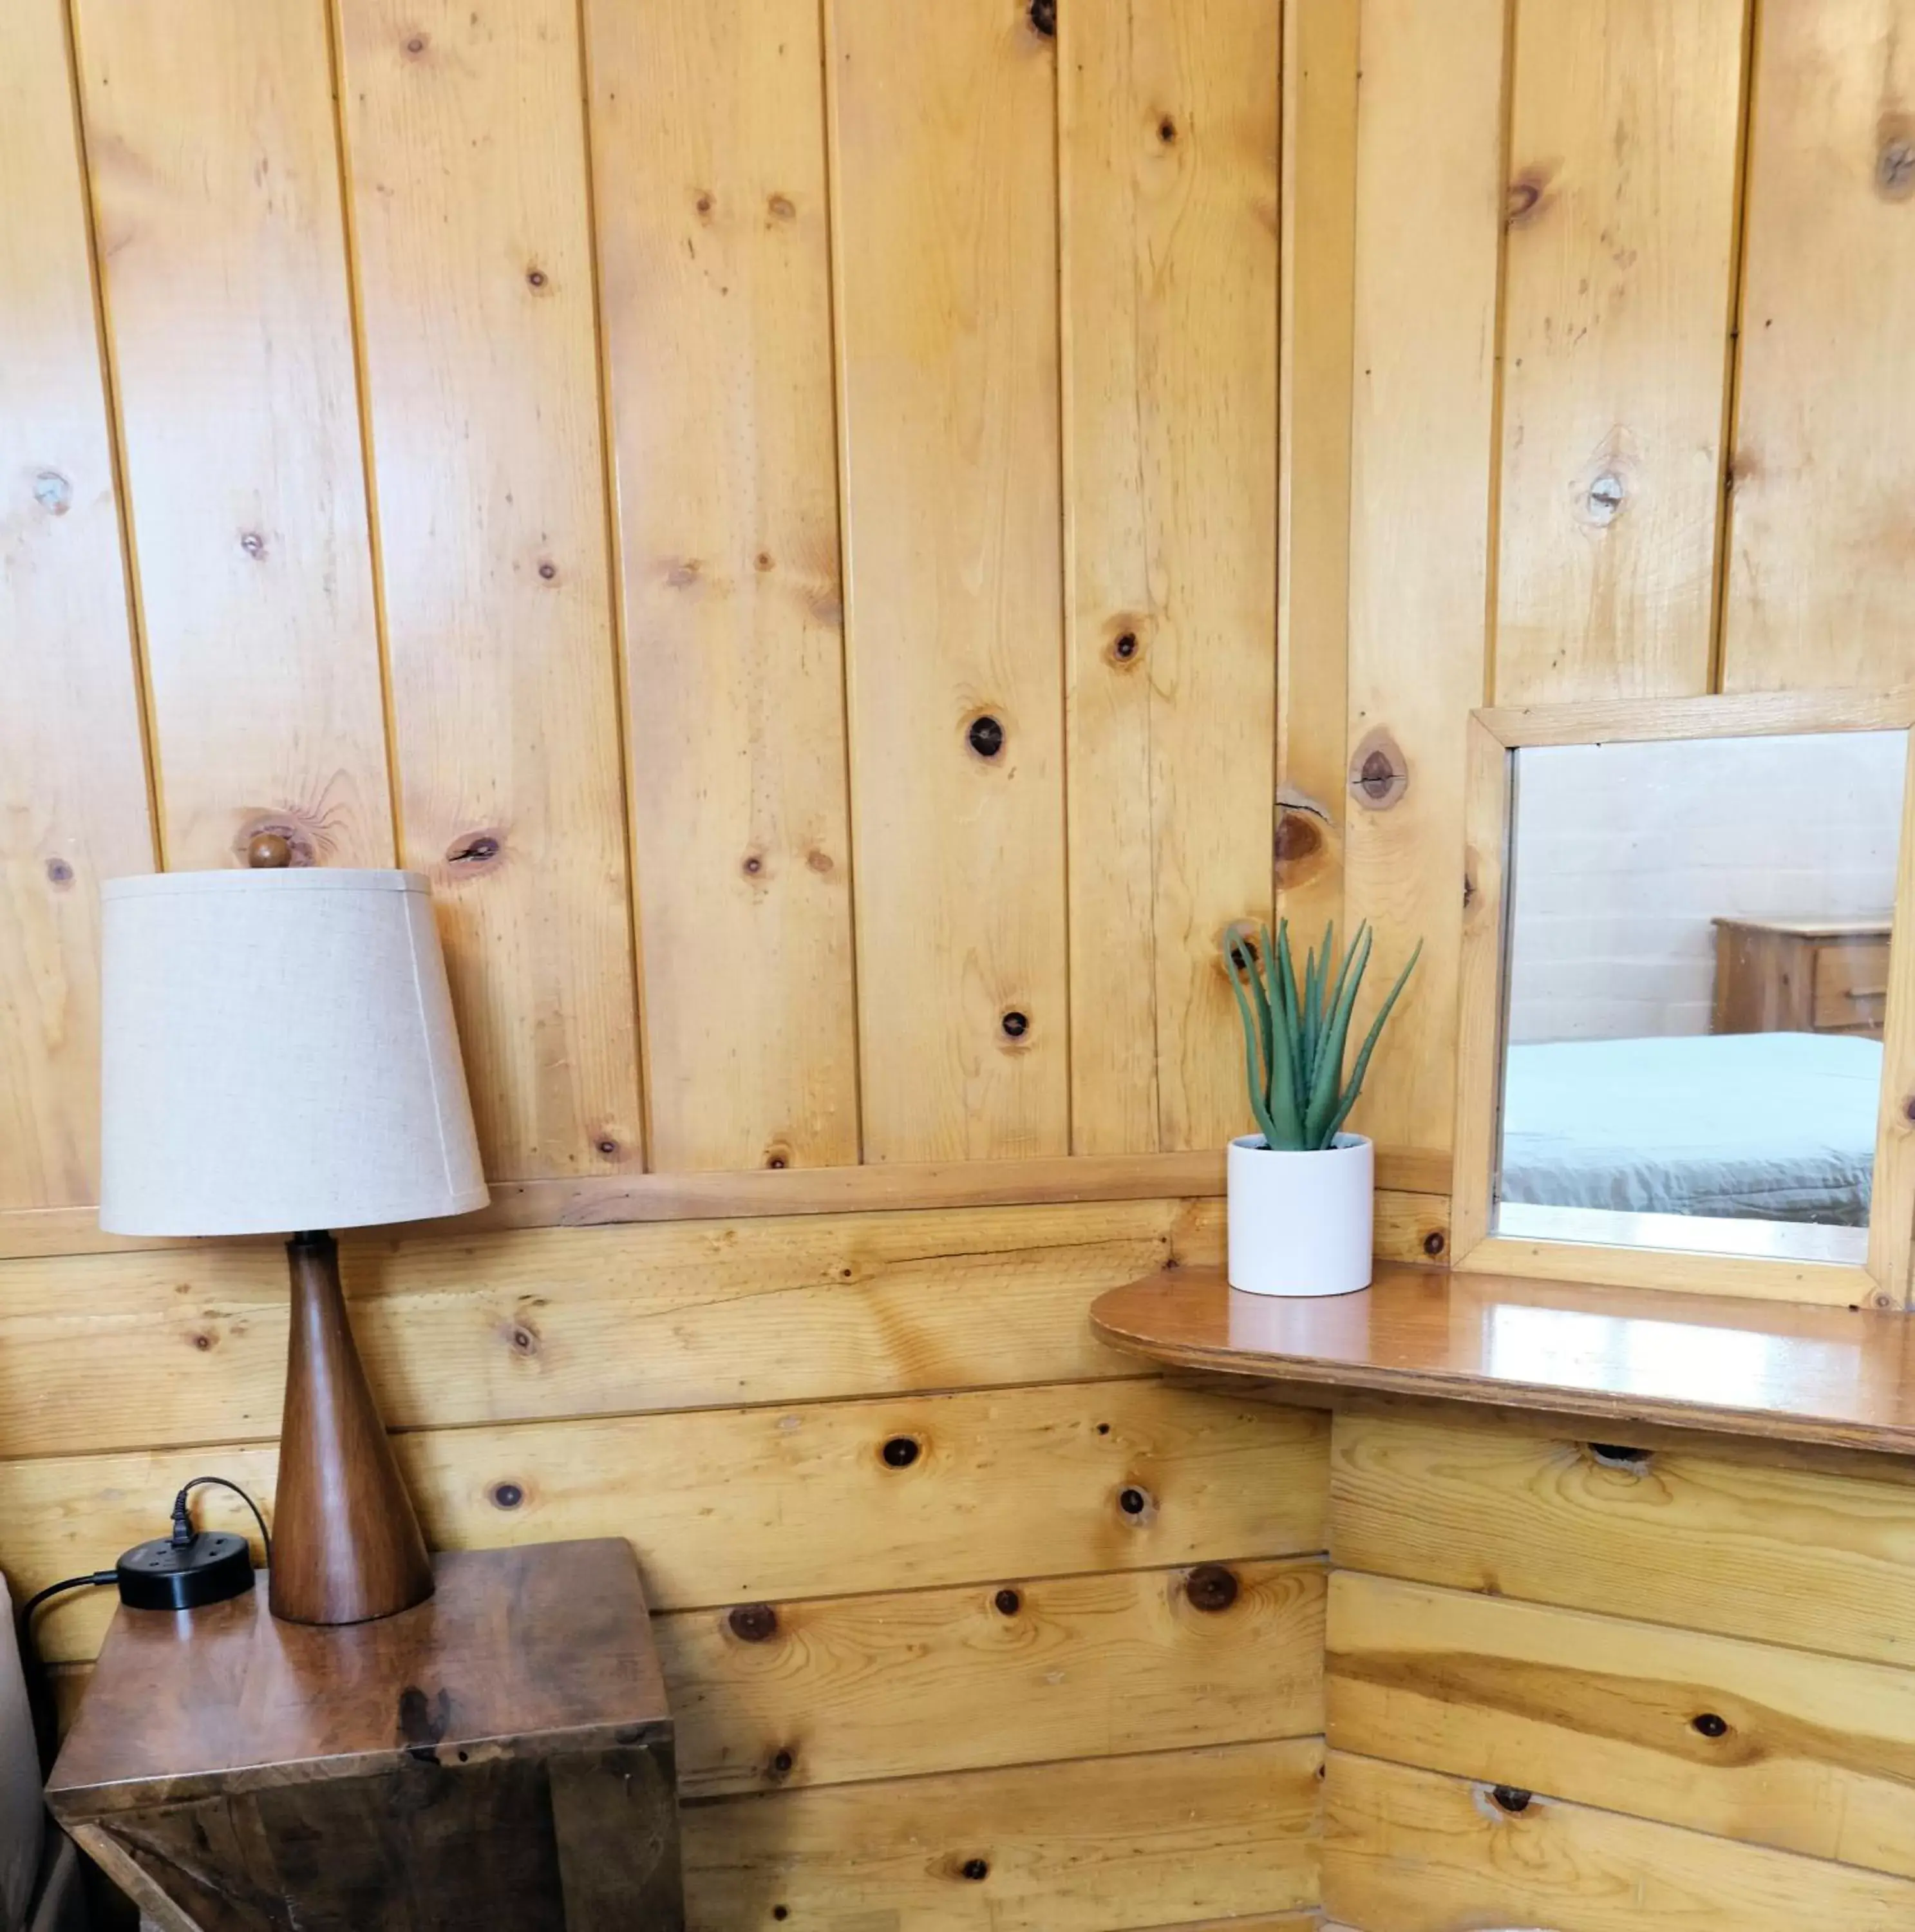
[[46, 1540, 668, 1824]]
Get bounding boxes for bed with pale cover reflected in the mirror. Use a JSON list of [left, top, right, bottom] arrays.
[[1502, 1034, 1882, 1227]]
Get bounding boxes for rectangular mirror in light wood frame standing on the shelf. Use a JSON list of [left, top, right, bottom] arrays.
[[1453, 690, 1915, 1308]]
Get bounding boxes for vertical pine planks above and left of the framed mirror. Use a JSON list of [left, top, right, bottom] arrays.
[[1321, 0, 1915, 1157]]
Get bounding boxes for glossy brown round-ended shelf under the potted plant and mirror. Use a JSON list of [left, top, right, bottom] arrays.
[[1090, 1265, 1915, 1453]]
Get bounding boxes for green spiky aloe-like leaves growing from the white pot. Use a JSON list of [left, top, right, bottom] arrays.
[[1223, 920, 1422, 1153]]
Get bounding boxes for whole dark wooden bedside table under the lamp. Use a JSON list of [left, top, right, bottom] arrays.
[[46, 1540, 684, 1932]]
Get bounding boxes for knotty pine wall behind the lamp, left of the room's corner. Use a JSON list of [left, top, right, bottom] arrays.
[[0, 0, 1321, 1932]]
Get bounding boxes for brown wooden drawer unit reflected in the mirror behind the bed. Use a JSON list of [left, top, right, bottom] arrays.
[[1710, 912, 1892, 1039]]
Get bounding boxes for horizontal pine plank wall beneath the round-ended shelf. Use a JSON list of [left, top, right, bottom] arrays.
[[1324, 1408, 1915, 1932]]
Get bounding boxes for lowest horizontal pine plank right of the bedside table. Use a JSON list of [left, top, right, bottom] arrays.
[[684, 1739, 1322, 1932]]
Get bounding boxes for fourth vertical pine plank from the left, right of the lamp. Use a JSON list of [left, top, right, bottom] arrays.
[[587, 0, 858, 1171]]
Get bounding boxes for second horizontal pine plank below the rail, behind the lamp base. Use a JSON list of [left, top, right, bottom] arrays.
[[11, 1381, 1328, 1662]]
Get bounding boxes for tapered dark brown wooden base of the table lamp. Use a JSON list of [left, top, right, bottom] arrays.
[[269, 1233, 433, 1623]]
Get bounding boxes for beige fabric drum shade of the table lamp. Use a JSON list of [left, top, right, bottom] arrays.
[[100, 867, 487, 1235]]
